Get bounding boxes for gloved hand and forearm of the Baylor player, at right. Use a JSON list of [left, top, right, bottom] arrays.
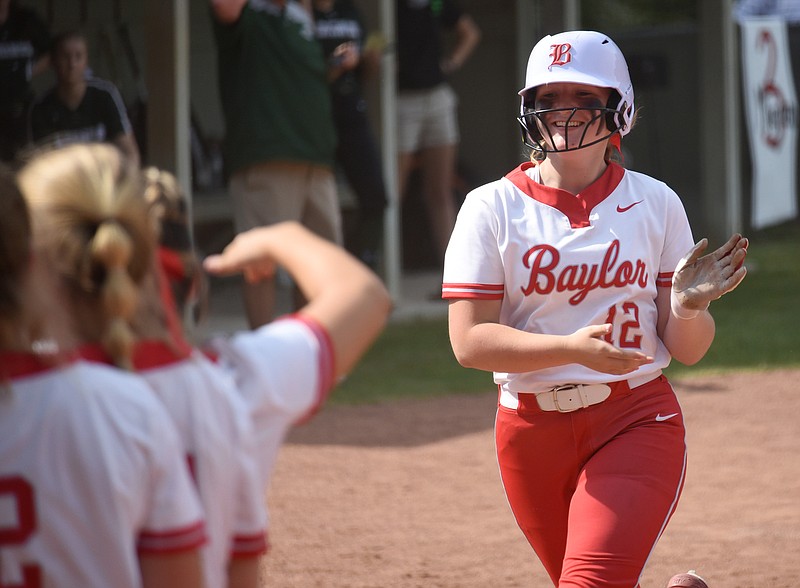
[[656, 233, 748, 365]]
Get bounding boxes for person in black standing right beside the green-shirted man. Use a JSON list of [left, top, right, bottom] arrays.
[[314, 0, 386, 270]]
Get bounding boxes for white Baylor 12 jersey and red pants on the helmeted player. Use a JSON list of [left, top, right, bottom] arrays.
[[443, 164, 693, 587]]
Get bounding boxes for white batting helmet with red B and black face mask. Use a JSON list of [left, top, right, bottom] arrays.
[[517, 31, 634, 160]]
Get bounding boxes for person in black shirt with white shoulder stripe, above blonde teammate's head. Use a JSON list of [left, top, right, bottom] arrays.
[[30, 31, 139, 166]]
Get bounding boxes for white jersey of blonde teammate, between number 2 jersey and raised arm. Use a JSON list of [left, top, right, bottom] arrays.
[[81, 341, 267, 588]]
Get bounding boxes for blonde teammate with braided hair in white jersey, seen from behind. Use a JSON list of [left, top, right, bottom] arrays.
[[20, 144, 266, 588]]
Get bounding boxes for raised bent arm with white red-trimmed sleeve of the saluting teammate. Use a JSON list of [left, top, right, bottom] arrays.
[[204, 222, 391, 487]]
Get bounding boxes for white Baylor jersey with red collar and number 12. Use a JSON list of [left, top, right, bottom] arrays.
[[442, 163, 693, 407]]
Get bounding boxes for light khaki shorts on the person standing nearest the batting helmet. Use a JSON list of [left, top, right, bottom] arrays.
[[397, 84, 459, 153]]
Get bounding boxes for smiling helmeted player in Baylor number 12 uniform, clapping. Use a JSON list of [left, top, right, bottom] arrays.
[[443, 31, 747, 587]]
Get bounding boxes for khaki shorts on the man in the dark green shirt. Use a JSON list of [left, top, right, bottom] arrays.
[[229, 162, 343, 245]]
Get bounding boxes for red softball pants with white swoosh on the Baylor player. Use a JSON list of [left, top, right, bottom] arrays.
[[495, 376, 686, 588]]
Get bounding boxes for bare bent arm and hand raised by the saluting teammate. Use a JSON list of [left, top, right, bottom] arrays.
[[203, 222, 392, 377]]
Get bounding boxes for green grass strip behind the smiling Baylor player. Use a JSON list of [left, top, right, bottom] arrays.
[[331, 223, 800, 404]]
